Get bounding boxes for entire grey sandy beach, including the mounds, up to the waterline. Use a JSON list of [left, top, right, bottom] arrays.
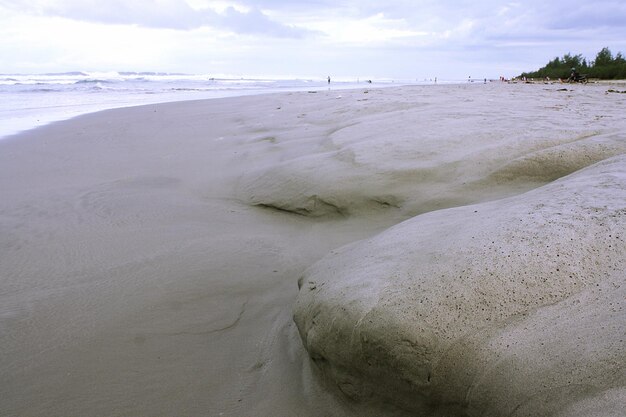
[[0, 83, 626, 417]]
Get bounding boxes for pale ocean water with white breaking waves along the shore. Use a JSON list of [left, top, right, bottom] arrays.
[[0, 72, 430, 139]]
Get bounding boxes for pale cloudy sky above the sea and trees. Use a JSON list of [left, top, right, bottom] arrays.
[[0, 0, 626, 80]]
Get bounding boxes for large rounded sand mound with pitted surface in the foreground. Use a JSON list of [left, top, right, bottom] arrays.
[[294, 156, 626, 416]]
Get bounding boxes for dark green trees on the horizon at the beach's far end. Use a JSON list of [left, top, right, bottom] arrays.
[[520, 47, 626, 80]]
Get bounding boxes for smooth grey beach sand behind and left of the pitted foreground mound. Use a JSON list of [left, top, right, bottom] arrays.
[[0, 84, 626, 417]]
